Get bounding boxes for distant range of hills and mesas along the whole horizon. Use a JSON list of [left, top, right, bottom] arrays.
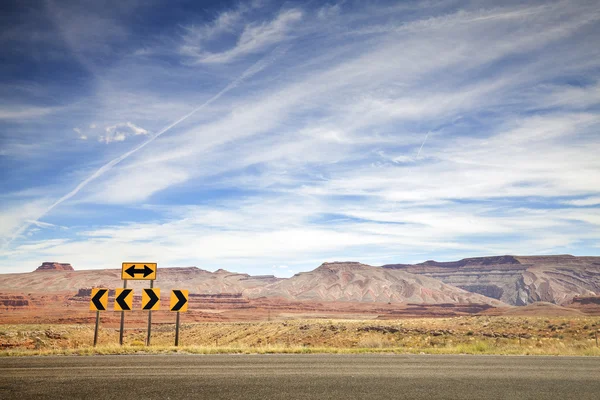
[[0, 255, 600, 306]]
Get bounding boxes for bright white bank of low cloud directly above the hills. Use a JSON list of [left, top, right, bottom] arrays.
[[0, 194, 600, 273]]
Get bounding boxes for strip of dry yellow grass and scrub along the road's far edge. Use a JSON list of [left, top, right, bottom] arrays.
[[0, 317, 600, 356]]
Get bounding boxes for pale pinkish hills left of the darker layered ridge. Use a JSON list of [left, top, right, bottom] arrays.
[[0, 262, 503, 306]]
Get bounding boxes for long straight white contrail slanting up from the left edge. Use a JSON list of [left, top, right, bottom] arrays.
[[3, 46, 289, 250]]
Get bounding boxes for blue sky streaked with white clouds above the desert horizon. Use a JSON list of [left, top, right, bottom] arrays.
[[0, 0, 600, 277]]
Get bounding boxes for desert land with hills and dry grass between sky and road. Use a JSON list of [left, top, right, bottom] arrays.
[[0, 256, 600, 356]]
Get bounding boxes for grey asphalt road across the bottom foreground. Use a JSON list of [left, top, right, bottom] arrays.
[[0, 355, 600, 400]]
